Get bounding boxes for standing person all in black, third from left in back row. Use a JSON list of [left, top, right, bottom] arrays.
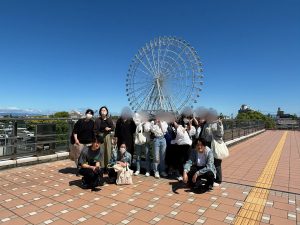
[[115, 107, 136, 155]]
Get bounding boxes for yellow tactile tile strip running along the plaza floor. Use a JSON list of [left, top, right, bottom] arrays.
[[234, 131, 288, 225]]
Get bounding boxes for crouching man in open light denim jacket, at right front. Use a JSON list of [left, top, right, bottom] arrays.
[[182, 138, 216, 192]]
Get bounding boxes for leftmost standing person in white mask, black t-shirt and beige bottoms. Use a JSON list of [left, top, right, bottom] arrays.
[[70, 109, 94, 169]]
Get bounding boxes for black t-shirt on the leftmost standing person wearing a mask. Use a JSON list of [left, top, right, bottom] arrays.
[[73, 119, 95, 144]]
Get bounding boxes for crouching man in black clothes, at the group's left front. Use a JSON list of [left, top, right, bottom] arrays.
[[78, 136, 103, 191]]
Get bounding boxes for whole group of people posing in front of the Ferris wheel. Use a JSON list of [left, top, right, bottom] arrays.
[[72, 106, 224, 191]]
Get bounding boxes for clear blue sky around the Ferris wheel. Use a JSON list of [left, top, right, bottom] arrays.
[[0, 0, 300, 115]]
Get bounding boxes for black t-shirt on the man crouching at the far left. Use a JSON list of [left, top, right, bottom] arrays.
[[78, 146, 102, 166]]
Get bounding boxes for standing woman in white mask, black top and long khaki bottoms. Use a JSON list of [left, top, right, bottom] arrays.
[[94, 106, 115, 168]]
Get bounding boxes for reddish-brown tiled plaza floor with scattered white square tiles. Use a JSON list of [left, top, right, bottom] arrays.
[[0, 131, 300, 225]]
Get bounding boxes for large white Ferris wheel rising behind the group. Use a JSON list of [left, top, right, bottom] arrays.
[[126, 37, 203, 113]]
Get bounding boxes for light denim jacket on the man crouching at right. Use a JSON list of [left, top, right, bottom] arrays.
[[184, 146, 216, 177]]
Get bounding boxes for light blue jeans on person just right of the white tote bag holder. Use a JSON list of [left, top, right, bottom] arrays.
[[153, 137, 167, 172]]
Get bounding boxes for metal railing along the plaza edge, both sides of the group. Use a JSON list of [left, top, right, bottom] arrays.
[[0, 118, 265, 160]]
